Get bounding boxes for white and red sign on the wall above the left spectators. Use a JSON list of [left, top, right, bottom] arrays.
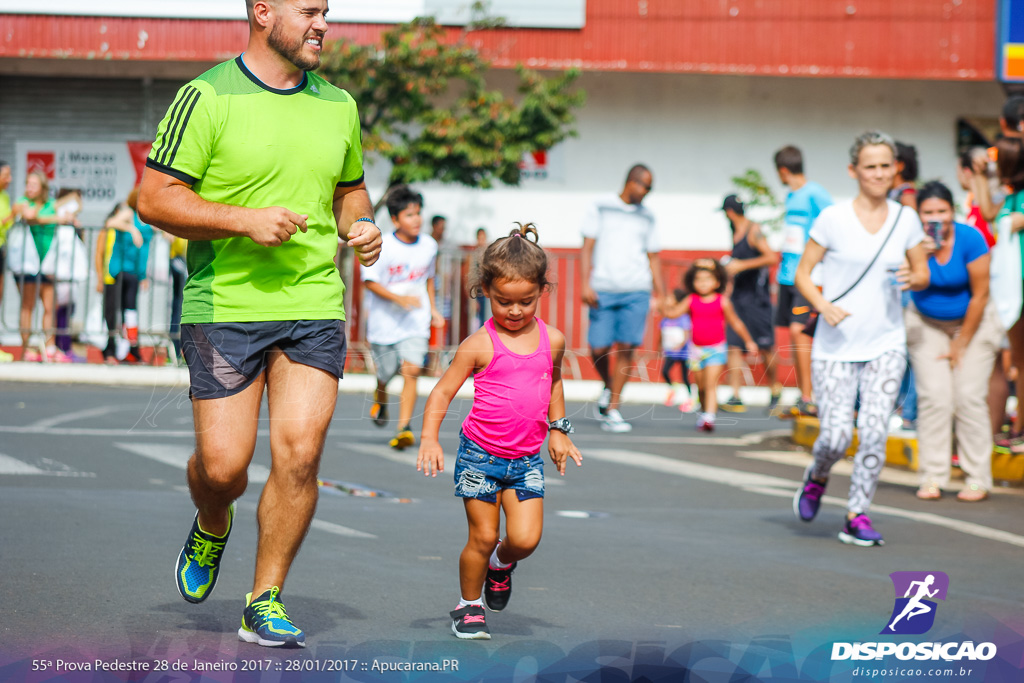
[[10, 140, 152, 225]]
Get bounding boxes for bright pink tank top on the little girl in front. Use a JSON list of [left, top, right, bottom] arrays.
[[462, 317, 552, 458]]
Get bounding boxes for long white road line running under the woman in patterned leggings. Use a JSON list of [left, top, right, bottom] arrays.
[[584, 449, 1024, 548]]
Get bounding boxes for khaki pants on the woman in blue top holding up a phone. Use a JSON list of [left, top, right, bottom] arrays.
[[903, 301, 1004, 490]]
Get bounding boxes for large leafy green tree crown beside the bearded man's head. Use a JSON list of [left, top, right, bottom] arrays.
[[319, 11, 585, 208]]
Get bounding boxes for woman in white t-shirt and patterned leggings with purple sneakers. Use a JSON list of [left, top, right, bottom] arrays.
[[793, 131, 929, 546]]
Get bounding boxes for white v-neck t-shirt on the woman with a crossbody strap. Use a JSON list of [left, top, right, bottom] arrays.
[[810, 200, 925, 362]]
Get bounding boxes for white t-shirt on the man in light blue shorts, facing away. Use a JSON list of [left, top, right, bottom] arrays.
[[582, 195, 662, 293]]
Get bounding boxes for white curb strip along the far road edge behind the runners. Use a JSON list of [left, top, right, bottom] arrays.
[[0, 362, 800, 407]]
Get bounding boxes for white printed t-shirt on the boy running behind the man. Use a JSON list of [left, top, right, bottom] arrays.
[[361, 232, 437, 344]]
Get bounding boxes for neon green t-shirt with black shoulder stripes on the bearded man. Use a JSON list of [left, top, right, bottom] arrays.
[[146, 57, 362, 323]]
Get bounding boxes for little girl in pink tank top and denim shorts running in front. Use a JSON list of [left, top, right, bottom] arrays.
[[416, 225, 583, 639]]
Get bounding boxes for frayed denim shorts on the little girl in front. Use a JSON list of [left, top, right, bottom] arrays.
[[455, 433, 544, 503]]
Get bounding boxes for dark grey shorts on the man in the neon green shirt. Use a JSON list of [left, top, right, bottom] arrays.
[[181, 321, 347, 399]]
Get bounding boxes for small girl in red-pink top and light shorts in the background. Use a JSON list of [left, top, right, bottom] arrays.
[[662, 258, 758, 432]]
